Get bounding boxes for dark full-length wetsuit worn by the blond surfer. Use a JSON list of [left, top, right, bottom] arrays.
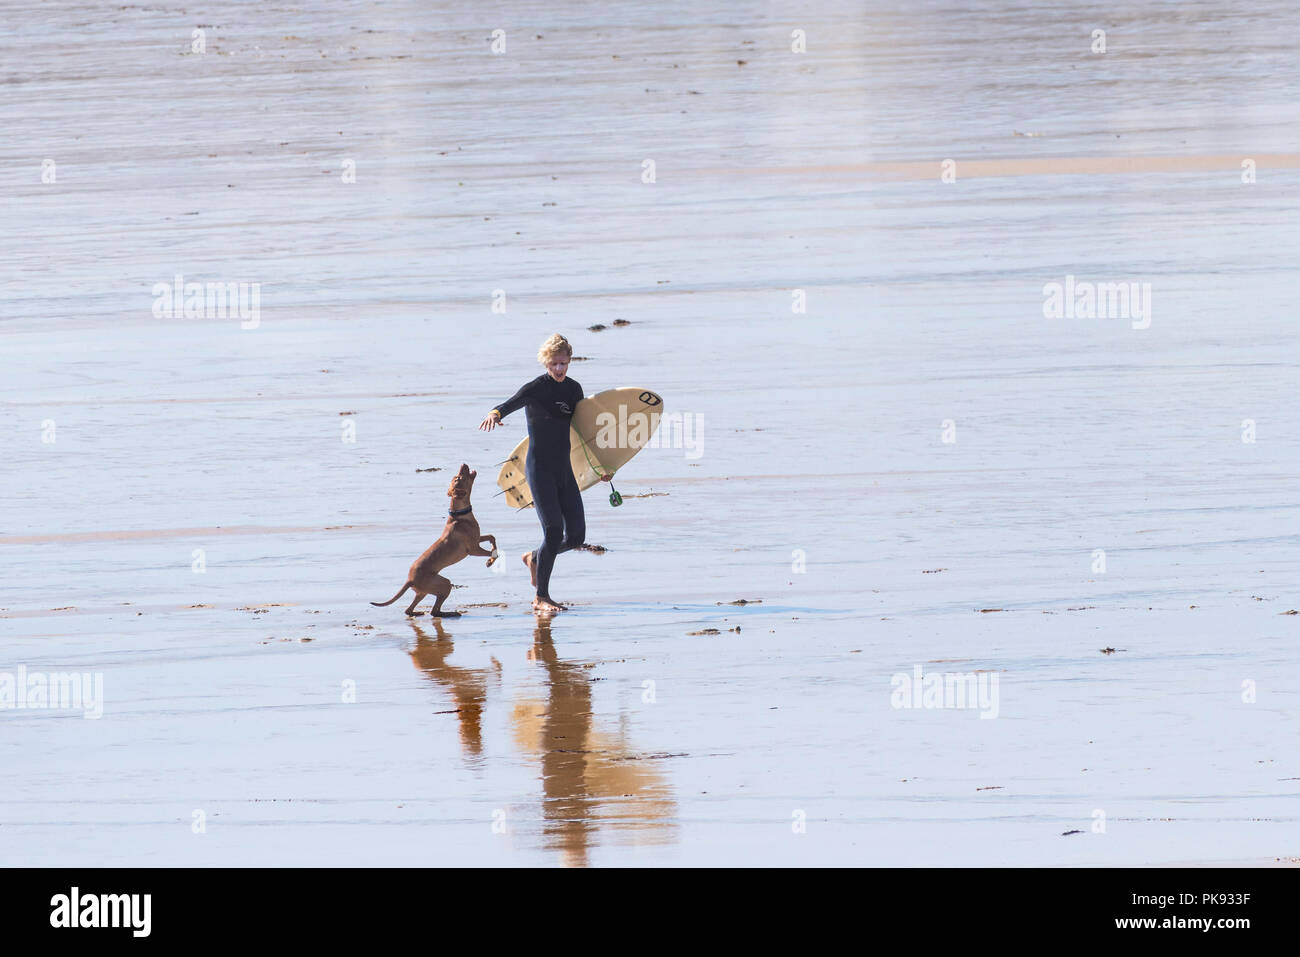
[[497, 373, 586, 601]]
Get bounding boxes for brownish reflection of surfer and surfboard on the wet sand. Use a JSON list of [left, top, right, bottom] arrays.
[[512, 618, 676, 866]]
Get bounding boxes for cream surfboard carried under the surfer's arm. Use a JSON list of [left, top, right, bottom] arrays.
[[497, 386, 663, 508]]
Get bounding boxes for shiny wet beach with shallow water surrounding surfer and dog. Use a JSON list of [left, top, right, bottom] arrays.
[[0, 1, 1300, 866]]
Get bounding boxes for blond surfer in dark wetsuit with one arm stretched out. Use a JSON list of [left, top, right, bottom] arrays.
[[478, 333, 614, 615]]
